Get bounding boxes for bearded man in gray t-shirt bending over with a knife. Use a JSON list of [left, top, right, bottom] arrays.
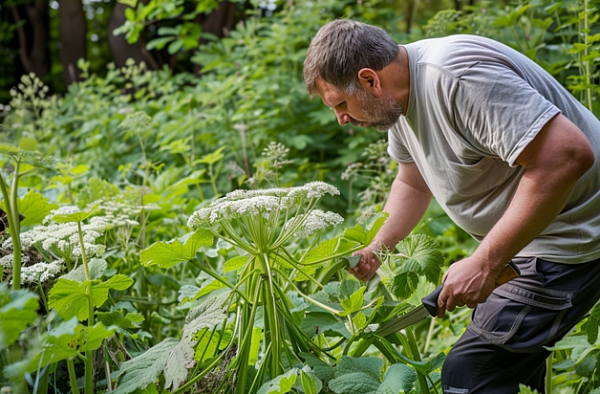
[[304, 20, 600, 394]]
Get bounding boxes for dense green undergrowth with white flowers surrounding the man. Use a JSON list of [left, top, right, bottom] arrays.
[[0, 1, 600, 394]]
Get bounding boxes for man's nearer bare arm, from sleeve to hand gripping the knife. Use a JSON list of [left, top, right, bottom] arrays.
[[438, 114, 594, 317]]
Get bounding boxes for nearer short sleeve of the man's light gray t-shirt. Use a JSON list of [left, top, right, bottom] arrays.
[[454, 62, 560, 166]]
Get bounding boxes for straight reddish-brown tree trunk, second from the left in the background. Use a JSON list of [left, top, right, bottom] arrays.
[[59, 0, 87, 85]]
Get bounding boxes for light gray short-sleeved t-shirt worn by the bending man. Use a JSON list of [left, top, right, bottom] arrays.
[[388, 35, 600, 263]]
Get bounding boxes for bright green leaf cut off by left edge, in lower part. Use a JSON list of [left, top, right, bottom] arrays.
[[0, 283, 39, 349]]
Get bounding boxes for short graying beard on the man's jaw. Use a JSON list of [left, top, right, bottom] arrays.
[[352, 89, 404, 131]]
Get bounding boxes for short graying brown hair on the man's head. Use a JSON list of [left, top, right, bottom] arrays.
[[304, 19, 398, 96]]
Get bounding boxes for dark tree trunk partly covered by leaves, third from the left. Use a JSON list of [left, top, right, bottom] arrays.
[[108, 2, 160, 70]]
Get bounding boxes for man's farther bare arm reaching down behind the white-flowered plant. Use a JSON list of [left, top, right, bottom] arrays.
[[350, 163, 431, 280]]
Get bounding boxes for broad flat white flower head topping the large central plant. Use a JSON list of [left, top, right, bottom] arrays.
[[188, 182, 340, 228]]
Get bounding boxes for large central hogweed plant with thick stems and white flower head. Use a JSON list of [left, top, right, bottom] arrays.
[[117, 182, 392, 394]]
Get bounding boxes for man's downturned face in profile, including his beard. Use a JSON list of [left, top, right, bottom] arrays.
[[317, 80, 403, 131]]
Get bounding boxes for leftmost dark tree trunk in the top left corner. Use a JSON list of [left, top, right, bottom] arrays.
[[11, 0, 50, 78]]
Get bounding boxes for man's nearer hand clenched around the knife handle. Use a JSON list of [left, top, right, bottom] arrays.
[[437, 256, 501, 317]]
